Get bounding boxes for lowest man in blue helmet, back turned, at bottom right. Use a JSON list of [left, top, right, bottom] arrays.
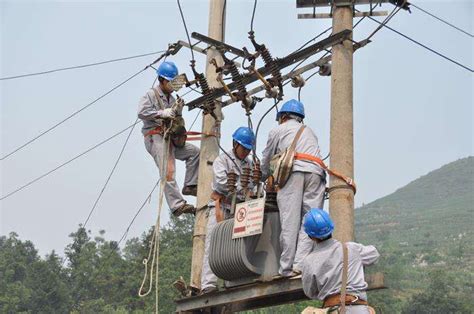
[[302, 208, 380, 314]]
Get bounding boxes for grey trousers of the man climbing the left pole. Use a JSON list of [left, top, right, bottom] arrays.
[[145, 134, 199, 212]]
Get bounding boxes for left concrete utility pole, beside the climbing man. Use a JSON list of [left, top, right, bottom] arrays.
[[191, 0, 226, 288]]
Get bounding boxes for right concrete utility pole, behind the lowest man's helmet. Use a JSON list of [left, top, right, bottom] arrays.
[[329, 1, 354, 242]]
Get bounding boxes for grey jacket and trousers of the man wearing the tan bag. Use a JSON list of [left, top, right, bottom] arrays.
[[262, 119, 326, 276]]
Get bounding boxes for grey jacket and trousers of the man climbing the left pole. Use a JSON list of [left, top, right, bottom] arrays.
[[138, 87, 199, 211]]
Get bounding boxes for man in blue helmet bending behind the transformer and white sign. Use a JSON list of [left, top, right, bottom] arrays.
[[201, 127, 255, 294]]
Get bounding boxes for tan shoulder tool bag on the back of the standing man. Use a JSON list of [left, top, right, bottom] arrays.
[[270, 125, 306, 189]]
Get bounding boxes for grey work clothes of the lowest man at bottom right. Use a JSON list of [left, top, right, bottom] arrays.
[[302, 239, 380, 314]]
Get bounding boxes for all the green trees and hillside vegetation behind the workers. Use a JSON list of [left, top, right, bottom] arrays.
[[0, 157, 474, 313]]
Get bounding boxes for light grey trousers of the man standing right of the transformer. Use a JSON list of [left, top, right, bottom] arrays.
[[277, 171, 326, 276]]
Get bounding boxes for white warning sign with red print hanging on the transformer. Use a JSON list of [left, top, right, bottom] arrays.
[[232, 198, 265, 239]]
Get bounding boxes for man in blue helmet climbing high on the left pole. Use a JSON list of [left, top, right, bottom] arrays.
[[138, 61, 199, 217]]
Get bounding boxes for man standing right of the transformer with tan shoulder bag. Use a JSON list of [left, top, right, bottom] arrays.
[[261, 99, 326, 277]]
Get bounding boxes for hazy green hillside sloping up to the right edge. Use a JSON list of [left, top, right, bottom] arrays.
[[355, 157, 474, 313]]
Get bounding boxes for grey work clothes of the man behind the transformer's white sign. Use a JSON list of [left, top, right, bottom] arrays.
[[201, 149, 253, 290]]
